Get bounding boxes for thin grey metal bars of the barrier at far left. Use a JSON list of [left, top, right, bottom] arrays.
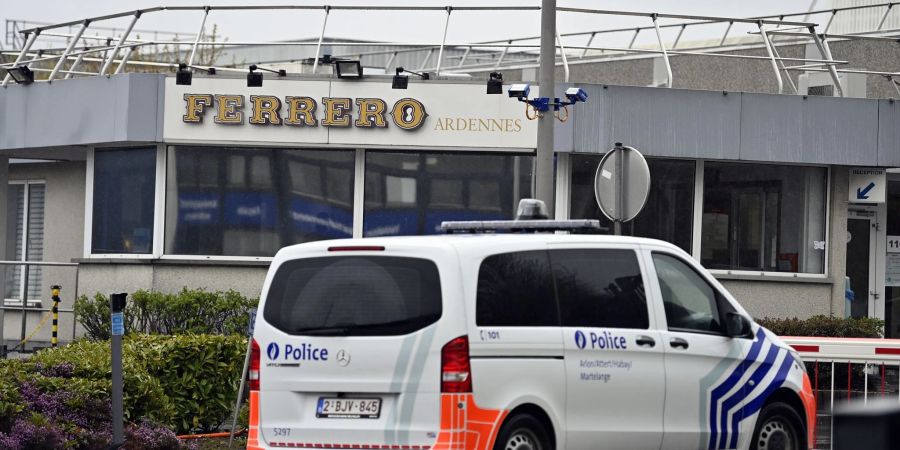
[[0, 261, 78, 357]]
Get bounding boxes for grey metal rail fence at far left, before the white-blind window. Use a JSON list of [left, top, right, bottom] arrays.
[[0, 261, 78, 357]]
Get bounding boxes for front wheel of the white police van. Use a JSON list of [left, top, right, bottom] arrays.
[[750, 402, 806, 450]]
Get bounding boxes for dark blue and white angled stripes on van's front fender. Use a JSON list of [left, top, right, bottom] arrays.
[[708, 327, 794, 450]]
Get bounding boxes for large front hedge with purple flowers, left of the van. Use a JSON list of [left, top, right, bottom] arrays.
[[0, 335, 247, 450]]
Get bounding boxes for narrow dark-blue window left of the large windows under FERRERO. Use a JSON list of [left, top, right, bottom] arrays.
[[91, 147, 156, 253]]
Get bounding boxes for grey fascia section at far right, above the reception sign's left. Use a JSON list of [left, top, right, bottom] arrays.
[[740, 94, 878, 165]]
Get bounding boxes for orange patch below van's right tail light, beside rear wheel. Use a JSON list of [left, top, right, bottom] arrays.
[[432, 394, 509, 450]]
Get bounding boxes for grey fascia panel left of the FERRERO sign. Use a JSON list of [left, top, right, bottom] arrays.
[[0, 74, 164, 149]]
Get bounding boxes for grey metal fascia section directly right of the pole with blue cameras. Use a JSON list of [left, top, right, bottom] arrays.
[[575, 86, 741, 159]]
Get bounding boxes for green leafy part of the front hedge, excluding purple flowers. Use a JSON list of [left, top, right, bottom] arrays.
[[0, 335, 247, 438]]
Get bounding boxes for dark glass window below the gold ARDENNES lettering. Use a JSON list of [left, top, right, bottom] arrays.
[[363, 152, 533, 236]]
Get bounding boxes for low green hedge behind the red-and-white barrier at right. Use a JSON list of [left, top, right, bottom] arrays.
[[757, 315, 884, 338]]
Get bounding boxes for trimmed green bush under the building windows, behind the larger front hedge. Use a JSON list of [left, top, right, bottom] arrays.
[[74, 288, 258, 340]]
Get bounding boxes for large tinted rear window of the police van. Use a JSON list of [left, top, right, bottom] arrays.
[[263, 256, 441, 336]]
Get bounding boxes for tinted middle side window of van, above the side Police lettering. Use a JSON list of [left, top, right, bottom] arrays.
[[550, 249, 650, 328]]
